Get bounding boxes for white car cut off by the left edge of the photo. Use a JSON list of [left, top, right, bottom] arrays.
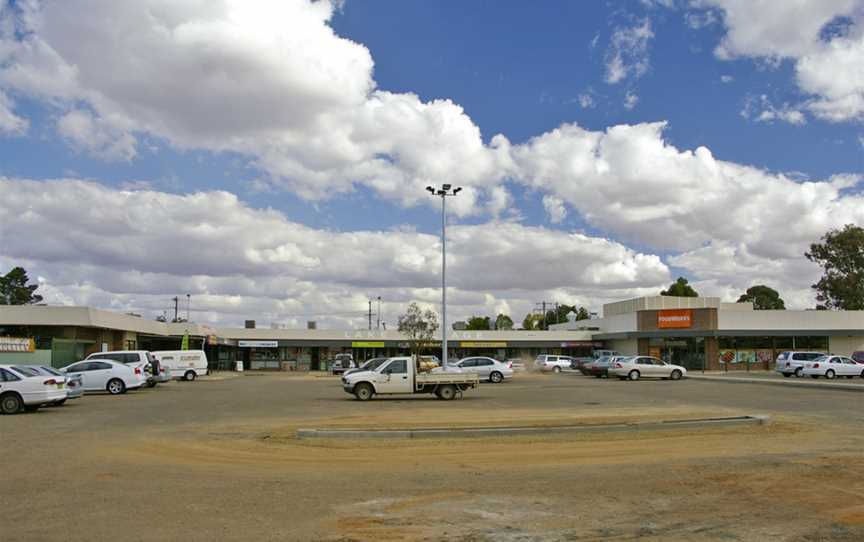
[[0, 365, 66, 414]]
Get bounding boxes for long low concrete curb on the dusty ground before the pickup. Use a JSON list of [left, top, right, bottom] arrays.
[[297, 415, 770, 439]]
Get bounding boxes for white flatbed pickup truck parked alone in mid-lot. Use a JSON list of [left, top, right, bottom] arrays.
[[342, 356, 480, 401]]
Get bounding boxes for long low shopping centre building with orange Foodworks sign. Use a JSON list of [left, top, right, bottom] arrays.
[[0, 296, 864, 370]]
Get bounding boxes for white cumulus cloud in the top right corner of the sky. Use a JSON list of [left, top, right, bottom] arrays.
[[696, 0, 864, 122]]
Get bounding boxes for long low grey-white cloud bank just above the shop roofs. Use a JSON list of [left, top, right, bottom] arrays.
[[0, 179, 670, 325]]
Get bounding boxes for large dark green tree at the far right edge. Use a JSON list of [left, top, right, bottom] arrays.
[[804, 224, 864, 311]]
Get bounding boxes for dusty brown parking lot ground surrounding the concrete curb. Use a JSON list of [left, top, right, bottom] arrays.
[[0, 374, 864, 541]]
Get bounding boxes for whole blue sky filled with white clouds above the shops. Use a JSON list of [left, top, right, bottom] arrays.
[[0, 0, 864, 328]]
